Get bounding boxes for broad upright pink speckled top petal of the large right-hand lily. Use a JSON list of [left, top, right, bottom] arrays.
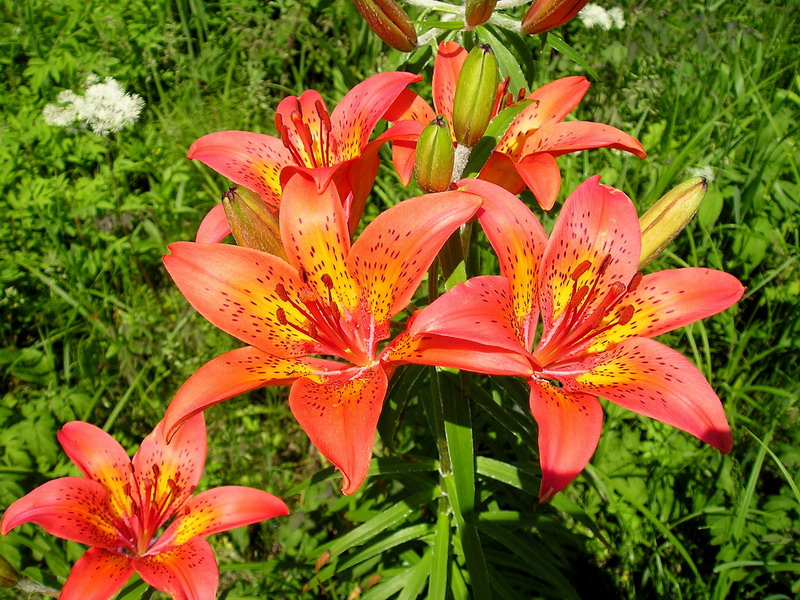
[[539, 175, 642, 338]]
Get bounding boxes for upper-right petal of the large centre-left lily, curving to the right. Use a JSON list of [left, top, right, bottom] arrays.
[[347, 192, 481, 324]]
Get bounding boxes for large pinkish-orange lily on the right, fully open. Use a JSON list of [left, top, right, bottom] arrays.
[[406, 176, 744, 502]]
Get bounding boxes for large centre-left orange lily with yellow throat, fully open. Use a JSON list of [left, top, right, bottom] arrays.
[[164, 173, 481, 494]]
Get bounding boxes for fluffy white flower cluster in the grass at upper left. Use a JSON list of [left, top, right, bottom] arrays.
[[42, 75, 144, 135]]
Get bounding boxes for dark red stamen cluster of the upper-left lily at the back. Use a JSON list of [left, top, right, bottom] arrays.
[[275, 99, 336, 168]]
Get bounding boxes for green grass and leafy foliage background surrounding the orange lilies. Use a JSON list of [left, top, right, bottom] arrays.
[[0, 0, 800, 599]]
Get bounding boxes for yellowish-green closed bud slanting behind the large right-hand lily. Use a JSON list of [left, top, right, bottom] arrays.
[[639, 177, 708, 269]]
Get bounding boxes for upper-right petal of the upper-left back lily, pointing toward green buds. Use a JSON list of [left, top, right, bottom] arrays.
[[331, 71, 422, 161]]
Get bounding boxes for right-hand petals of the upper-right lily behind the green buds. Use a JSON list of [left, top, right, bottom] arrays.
[[478, 77, 647, 210]]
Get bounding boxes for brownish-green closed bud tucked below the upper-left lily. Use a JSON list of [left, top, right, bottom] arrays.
[[222, 185, 286, 258]]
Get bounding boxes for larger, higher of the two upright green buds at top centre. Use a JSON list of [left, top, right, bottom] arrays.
[[453, 44, 500, 148]]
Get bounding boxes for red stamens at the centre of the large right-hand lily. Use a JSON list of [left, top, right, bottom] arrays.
[[534, 254, 642, 366]]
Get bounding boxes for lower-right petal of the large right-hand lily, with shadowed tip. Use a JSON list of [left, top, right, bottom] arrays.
[[564, 338, 733, 453]]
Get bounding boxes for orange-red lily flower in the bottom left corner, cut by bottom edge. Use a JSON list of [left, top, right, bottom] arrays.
[[0, 415, 289, 600]]
